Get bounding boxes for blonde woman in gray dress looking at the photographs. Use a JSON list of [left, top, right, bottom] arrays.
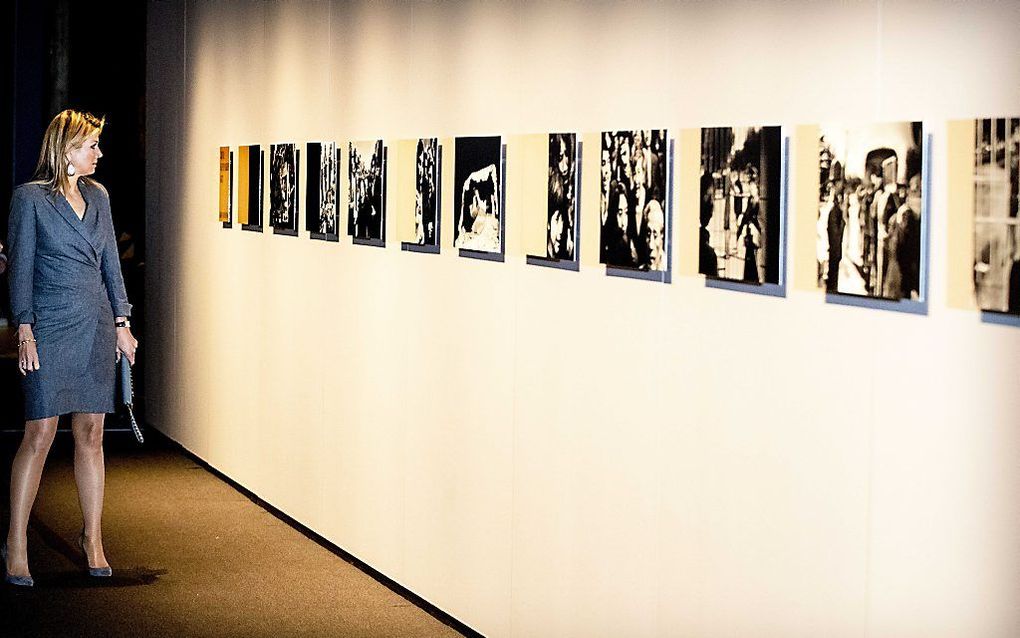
[[0, 110, 138, 586]]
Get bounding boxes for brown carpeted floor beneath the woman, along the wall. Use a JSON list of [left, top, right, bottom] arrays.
[[0, 432, 461, 638]]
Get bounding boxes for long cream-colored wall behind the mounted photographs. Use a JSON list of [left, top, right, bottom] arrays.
[[143, 1, 1020, 638]]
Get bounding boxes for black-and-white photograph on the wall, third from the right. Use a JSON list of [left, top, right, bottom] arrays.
[[698, 127, 782, 284]]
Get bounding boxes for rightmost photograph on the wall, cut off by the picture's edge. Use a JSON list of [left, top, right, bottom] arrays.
[[974, 117, 1020, 314]]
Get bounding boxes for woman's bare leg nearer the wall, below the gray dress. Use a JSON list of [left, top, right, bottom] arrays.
[[70, 413, 109, 568]]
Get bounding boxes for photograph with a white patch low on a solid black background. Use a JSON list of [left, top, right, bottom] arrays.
[[453, 137, 503, 253]]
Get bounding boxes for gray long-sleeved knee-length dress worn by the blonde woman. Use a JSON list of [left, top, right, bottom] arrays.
[[7, 178, 131, 421]]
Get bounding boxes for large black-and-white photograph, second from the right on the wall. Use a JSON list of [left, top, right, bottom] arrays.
[[816, 121, 924, 300]]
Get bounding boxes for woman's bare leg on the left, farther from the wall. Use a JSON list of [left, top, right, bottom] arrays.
[[7, 416, 57, 576]]
